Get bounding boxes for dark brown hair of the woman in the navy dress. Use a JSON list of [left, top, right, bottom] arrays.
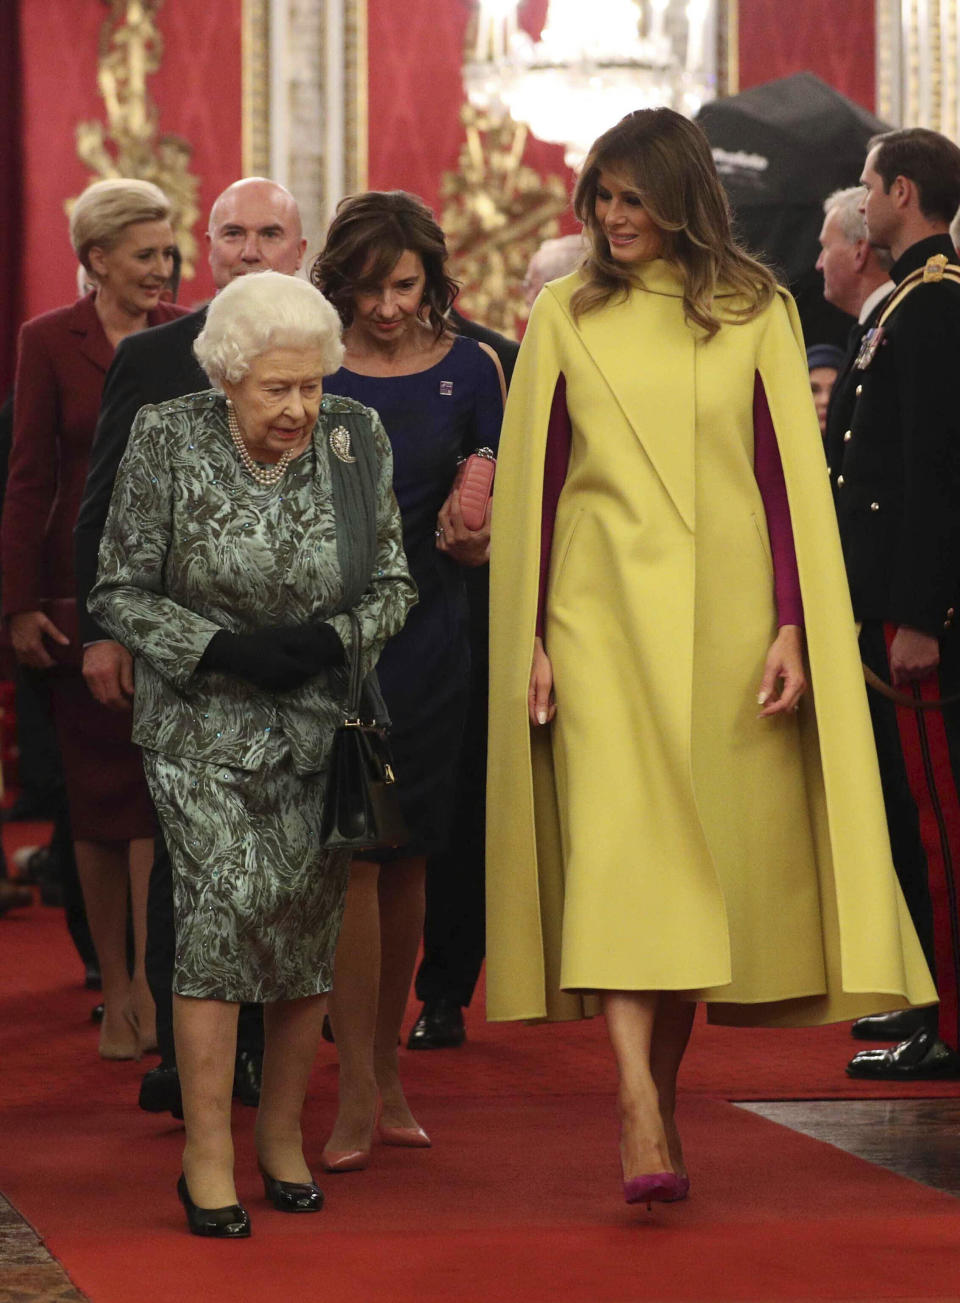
[[310, 190, 460, 339]]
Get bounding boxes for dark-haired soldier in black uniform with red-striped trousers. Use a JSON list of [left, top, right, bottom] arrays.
[[828, 128, 960, 1079]]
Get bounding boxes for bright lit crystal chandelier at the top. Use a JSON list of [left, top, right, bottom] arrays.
[[464, 0, 716, 169]]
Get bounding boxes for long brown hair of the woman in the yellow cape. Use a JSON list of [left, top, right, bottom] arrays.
[[571, 108, 776, 339]]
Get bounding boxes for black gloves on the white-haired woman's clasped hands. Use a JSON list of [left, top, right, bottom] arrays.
[[198, 624, 344, 692]]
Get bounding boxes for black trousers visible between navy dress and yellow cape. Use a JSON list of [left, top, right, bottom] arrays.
[[416, 566, 490, 1006]]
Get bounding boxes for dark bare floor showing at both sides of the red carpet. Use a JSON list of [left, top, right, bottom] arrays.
[[0, 1098, 960, 1303]]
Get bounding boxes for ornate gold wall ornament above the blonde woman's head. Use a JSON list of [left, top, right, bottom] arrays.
[[74, 0, 199, 280]]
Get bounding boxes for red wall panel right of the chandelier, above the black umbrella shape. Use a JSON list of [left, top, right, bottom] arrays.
[[739, 0, 877, 111]]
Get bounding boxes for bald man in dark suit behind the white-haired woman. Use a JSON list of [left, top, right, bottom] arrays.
[[74, 177, 306, 1115]]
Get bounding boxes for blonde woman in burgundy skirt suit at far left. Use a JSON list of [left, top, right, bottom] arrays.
[[0, 179, 184, 1059]]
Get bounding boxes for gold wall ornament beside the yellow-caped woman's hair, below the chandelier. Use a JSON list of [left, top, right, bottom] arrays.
[[440, 104, 571, 335]]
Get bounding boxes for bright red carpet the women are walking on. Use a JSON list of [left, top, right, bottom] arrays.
[[0, 891, 960, 1303]]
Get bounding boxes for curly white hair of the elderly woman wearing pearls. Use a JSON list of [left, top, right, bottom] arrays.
[[193, 271, 344, 390]]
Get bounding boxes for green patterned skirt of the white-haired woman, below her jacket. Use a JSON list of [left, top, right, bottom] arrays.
[[143, 735, 349, 1002]]
